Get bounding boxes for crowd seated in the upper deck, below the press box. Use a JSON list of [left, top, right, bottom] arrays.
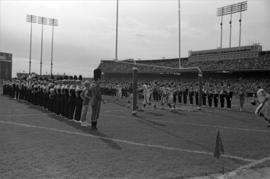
[[100, 53, 270, 73]]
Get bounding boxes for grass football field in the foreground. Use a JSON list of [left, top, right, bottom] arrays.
[[0, 93, 270, 178]]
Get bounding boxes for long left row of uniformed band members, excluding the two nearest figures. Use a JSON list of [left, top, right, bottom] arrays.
[[3, 80, 84, 121]]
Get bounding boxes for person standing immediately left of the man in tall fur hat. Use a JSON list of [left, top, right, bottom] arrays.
[[80, 81, 91, 126]]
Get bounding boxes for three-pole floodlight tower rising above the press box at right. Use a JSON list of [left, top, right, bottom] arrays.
[[217, 1, 247, 48]]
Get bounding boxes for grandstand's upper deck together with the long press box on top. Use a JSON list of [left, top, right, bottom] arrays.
[[99, 45, 270, 78]]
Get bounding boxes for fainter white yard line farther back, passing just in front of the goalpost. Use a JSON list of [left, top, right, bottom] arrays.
[[101, 114, 270, 133]]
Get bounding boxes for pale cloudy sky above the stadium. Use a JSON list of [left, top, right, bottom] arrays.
[[0, 0, 270, 77]]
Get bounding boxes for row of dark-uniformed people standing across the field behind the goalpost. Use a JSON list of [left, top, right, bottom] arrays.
[[109, 83, 233, 108]]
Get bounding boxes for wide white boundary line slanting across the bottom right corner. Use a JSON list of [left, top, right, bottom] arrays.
[[217, 157, 270, 179]]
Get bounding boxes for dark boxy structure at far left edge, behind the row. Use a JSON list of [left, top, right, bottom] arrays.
[[0, 52, 12, 83]]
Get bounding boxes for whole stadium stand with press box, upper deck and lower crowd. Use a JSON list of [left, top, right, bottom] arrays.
[[99, 44, 270, 96]]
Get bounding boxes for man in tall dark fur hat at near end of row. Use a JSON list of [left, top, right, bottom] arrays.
[[90, 68, 102, 129]]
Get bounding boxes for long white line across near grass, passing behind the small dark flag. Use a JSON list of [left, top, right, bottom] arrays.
[[0, 121, 256, 162]]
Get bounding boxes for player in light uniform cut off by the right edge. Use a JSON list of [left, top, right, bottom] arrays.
[[255, 89, 270, 127]]
